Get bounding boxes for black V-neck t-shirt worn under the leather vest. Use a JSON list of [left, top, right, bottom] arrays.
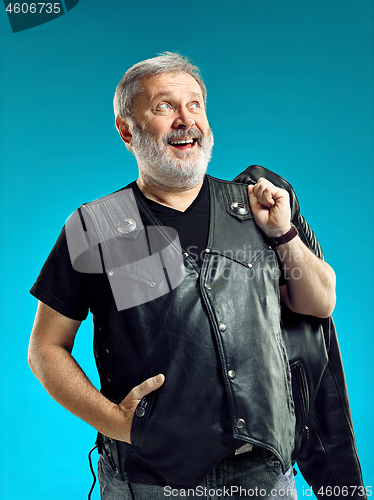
[[30, 179, 209, 321]]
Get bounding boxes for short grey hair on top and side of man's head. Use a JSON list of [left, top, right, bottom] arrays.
[[113, 52, 207, 124]]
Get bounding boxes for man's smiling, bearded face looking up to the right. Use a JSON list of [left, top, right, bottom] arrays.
[[120, 73, 213, 190]]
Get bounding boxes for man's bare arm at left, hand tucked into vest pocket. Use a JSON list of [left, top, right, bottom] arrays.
[[29, 302, 165, 443]]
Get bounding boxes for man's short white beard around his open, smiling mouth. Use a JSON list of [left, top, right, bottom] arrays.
[[132, 124, 214, 191]]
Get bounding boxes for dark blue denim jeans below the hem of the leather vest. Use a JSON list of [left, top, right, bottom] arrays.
[[98, 448, 297, 500]]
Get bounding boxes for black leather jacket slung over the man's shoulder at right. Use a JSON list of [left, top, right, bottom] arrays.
[[234, 165, 366, 500]]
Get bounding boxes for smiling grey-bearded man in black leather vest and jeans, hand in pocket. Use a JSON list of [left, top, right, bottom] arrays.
[[29, 53, 362, 500]]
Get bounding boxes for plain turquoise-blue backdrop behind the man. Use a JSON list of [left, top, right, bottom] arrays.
[[0, 0, 374, 500]]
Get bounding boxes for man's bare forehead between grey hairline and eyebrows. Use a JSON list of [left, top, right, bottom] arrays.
[[136, 73, 202, 104]]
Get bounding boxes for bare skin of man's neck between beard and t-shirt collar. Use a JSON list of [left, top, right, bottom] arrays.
[[136, 175, 204, 212]]
